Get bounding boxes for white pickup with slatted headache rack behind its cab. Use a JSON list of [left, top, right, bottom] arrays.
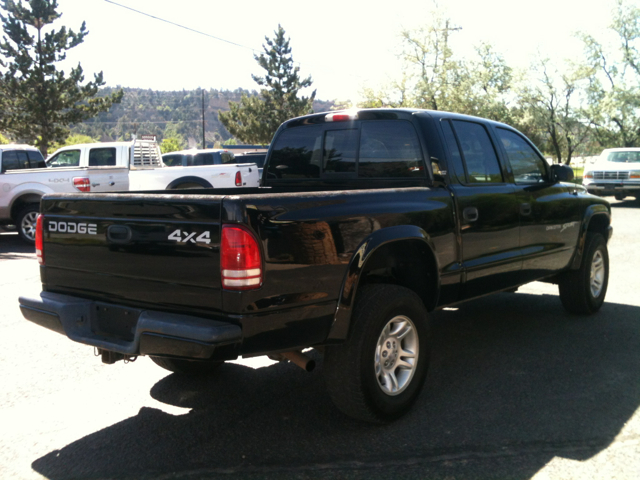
[[47, 140, 260, 191]]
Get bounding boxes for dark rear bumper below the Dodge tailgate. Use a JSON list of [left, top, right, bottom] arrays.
[[19, 292, 242, 359]]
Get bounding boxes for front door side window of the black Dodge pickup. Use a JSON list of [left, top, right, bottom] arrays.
[[496, 128, 549, 184]]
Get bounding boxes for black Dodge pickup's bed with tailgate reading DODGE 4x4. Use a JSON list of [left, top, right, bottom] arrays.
[[42, 187, 456, 354]]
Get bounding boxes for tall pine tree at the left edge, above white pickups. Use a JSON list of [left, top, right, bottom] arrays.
[[0, 0, 122, 155]]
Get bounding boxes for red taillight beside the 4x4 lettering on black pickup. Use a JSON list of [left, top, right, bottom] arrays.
[[220, 225, 262, 290]]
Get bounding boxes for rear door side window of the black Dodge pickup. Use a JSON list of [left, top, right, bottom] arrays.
[[452, 120, 504, 184]]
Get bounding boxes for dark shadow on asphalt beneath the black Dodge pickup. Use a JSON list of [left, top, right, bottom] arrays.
[[32, 293, 640, 479]]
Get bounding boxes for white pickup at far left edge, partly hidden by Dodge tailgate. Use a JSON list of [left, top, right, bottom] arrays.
[[0, 145, 129, 243]]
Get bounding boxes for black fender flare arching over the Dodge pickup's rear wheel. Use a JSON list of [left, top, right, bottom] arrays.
[[327, 225, 440, 343]]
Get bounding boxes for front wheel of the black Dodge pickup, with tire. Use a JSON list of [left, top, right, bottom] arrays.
[[558, 232, 609, 315]]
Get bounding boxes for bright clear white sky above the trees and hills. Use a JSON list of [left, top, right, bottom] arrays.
[[51, 0, 620, 100]]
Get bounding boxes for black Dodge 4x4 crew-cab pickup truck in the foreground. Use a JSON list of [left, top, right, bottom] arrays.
[[20, 109, 612, 422]]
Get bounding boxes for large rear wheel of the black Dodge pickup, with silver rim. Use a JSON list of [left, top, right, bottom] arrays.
[[323, 284, 430, 423]]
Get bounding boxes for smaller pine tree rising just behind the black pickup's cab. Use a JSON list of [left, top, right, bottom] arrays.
[[218, 25, 316, 144]]
